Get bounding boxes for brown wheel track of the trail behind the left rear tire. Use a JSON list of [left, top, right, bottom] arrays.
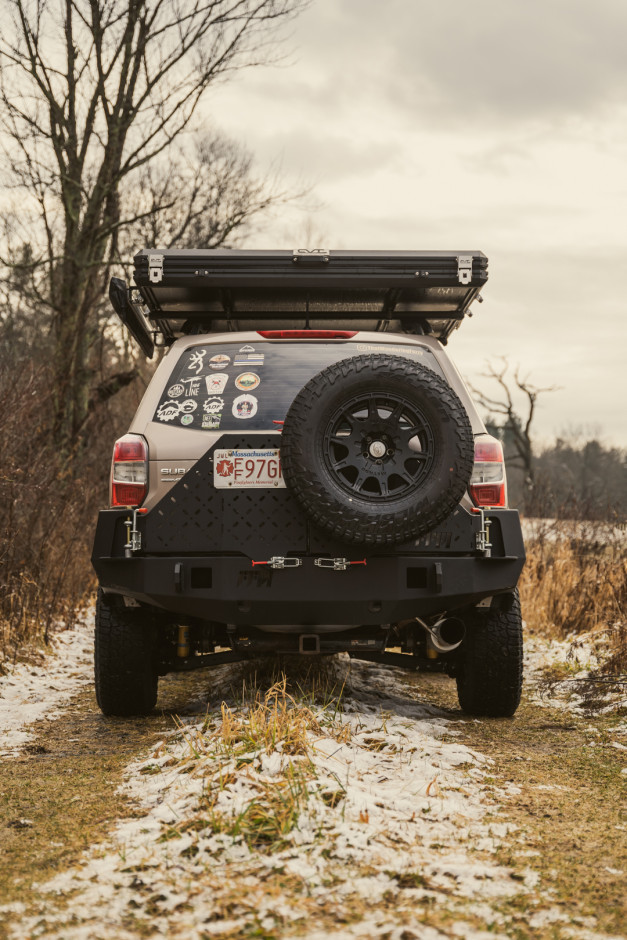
[[0, 670, 244, 916]]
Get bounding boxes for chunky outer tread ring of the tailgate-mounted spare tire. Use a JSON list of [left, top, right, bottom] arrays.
[[281, 355, 474, 545]]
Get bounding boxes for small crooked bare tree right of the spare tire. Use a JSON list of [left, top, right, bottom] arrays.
[[471, 356, 558, 507]]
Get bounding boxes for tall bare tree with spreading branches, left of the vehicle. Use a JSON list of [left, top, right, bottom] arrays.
[[0, 0, 306, 442]]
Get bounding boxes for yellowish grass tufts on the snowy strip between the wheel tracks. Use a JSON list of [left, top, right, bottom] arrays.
[[159, 671, 350, 851]]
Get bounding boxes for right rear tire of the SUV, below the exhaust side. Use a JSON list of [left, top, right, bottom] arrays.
[[457, 590, 523, 718]]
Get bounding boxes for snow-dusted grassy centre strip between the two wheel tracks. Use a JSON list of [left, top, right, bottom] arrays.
[[14, 659, 535, 940]]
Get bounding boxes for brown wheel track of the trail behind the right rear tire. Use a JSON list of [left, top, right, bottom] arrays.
[[414, 676, 627, 937]]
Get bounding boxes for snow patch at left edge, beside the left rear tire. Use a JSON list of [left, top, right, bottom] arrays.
[[0, 612, 94, 757]]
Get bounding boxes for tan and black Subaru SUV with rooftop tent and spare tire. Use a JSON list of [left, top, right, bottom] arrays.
[[93, 250, 524, 715]]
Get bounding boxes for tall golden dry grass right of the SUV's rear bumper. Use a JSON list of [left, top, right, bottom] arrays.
[[520, 522, 627, 673]]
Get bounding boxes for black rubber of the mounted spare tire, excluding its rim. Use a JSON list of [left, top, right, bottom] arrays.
[[281, 355, 474, 544]]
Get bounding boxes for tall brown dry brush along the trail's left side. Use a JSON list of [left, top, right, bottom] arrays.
[[0, 363, 144, 660]]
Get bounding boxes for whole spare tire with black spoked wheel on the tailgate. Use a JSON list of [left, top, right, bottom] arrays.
[[281, 355, 474, 545]]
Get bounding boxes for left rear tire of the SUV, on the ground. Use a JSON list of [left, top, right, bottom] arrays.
[[94, 589, 159, 717]]
